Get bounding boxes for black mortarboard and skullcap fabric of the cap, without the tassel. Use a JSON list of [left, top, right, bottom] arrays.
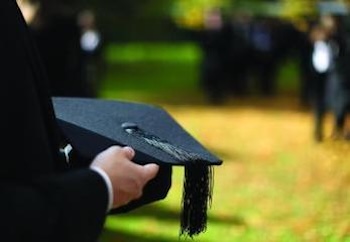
[[53, 97, 221, 165]]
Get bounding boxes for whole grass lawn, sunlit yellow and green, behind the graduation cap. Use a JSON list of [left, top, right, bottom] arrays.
[[100, 42, 350, 242]]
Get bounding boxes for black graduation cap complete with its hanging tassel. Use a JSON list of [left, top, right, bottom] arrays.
[[52, 97, 222, 237]]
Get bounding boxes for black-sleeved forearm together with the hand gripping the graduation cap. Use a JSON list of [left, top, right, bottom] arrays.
[[0, 147, 158, 242]]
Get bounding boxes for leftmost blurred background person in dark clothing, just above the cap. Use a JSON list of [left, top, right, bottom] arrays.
[[19, 0, 92, 97]]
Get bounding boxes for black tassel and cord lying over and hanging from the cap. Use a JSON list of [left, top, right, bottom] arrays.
[[125, 126, 213, 238]]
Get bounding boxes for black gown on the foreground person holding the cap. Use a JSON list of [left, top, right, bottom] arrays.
[[0, 0, 108, 242]]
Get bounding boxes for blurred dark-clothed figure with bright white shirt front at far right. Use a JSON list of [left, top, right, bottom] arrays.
[[310, 14, 350, 141]]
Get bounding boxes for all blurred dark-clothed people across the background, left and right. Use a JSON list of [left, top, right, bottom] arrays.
[[17, 0, 350, 141]]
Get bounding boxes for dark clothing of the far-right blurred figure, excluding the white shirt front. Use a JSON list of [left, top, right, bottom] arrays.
[[312, 20, 350, 139]]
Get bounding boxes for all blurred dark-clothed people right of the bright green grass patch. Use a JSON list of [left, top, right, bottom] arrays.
[[195, 9, 350, 141]]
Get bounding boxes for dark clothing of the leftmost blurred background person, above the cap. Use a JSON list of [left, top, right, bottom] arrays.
[[31, 13, 91, 97]]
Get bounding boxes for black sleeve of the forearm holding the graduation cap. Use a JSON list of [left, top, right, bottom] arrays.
[[0, 169, 108, 242]]
